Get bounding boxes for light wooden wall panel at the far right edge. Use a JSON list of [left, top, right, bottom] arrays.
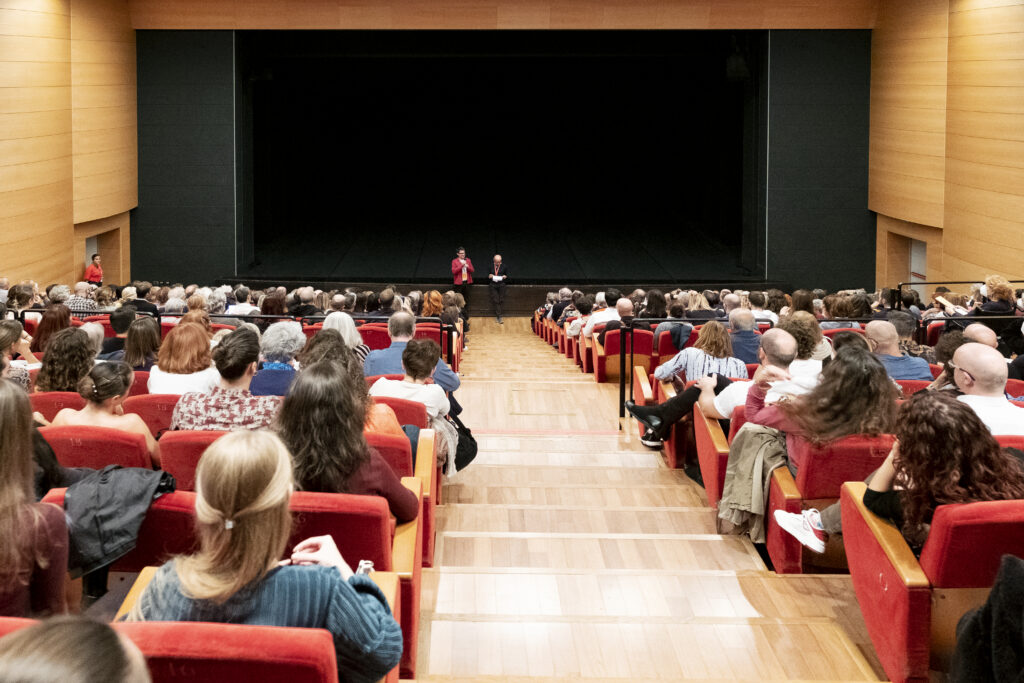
[[944, 0, 1024, 279]]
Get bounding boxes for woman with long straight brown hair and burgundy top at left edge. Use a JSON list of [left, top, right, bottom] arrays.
[[0, 382, 68, 618]]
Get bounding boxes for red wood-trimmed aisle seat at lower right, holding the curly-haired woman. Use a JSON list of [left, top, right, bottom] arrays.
[[842, 481, 1024, 683]]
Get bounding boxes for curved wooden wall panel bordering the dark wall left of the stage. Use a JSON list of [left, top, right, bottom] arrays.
[[71, 0, 138, 223]]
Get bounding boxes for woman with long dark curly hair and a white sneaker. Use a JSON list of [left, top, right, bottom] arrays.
[[775, 391, 1024, 553]]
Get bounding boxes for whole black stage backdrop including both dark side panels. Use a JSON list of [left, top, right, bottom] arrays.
[[132, 31, 873, 287]]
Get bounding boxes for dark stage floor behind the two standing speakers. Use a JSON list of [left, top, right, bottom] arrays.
[[239, 226, 752, 284]]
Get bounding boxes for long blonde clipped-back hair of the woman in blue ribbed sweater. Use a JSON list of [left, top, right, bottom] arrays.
[[166, 430, 294, 604]]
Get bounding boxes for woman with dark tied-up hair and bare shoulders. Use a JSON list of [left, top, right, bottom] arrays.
[[51, 360, 160, 466]]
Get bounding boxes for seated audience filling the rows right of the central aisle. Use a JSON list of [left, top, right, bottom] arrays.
[[536, 275, 1024, 553]]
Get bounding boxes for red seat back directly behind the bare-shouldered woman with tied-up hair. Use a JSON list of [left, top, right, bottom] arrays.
[[39, 425, 153, 470]]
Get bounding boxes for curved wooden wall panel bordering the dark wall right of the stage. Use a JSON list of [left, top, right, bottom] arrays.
[[868, 0, 948, 229]]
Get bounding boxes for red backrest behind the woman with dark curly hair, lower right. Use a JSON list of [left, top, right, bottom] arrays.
[[921, 501, 1024, 588]]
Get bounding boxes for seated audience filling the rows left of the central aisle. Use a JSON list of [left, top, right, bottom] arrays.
[[0, 279, 477, 681]]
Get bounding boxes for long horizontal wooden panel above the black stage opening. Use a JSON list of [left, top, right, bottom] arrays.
[[129, 0, 877, 30]]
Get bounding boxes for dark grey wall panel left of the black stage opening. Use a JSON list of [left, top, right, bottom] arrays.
[[131, 31, 236, 282]]
